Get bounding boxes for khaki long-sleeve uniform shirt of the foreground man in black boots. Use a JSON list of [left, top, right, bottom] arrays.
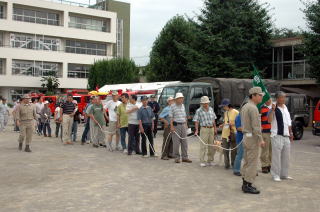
[[241, 100, 263, 142]]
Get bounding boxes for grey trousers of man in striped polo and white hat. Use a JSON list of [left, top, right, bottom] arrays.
[[172, 124, 188, 159]]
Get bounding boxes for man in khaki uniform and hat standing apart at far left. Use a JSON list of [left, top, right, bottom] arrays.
[[16, 94, 38, 152]]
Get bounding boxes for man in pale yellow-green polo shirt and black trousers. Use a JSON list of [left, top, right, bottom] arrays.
[[127, 95, 141, 155]]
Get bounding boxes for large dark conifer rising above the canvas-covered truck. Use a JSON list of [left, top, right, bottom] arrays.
[[180, 0, 272, 78]]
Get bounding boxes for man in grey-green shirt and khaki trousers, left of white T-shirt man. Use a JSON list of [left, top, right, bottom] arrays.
[[88, 96, 107, 148]]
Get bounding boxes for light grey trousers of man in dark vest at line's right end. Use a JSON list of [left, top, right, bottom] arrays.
[[271, 135, 290, 177]]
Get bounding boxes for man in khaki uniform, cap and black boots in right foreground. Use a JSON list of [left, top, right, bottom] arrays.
[[241, 87, 264, 194]]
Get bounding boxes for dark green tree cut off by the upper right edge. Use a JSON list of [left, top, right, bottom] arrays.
[[304, 0, 320, 83]]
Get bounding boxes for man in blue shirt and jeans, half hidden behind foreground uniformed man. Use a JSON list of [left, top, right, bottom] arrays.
[[233, 113, 243, 176]]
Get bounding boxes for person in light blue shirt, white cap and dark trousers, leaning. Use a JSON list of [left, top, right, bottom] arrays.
[[159, 96, 174, 160]]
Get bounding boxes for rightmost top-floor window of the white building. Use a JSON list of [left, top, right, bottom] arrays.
[[69, 16, 110, 32]]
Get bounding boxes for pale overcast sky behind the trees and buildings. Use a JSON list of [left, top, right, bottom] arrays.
[[73, 0, 308, 66]]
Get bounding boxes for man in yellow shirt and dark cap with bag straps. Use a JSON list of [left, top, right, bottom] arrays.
[[219, 99, 239, 169]]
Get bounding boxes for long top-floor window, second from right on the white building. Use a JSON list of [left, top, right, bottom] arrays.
[[13, 8, 60, 26]]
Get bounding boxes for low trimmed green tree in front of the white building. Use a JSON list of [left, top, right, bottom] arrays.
[[88, 58, 139, 90]]
